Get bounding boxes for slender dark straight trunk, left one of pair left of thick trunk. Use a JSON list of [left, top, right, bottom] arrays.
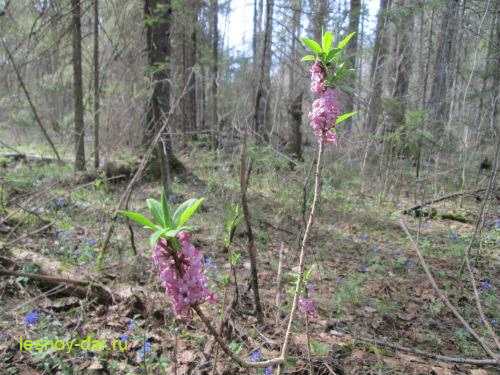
[[71, 0, 85, 171]]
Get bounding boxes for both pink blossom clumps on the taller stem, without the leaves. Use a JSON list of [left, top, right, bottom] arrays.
[[309, 61, 340, 143]]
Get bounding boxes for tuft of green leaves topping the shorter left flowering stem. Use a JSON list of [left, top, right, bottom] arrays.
[[120, 194, 204, 248]]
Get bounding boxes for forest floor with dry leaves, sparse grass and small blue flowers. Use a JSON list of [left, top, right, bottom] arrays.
[[0, 142, 500, 375]]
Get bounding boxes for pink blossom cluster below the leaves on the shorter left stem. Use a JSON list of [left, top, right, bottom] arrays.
[[153, 232, 216, 318]]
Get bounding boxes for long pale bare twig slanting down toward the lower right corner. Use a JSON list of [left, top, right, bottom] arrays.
[[399, 218, 500, 364]]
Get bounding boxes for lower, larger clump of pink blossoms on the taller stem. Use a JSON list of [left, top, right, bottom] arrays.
[[309, 87, 340, 143]]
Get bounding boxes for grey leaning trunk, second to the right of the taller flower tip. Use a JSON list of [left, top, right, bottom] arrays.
[[366, 0, 391, 133]]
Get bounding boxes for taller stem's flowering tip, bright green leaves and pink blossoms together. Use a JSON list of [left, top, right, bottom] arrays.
[[302, 32, 356, 143]]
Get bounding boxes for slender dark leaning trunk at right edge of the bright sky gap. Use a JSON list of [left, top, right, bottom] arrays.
[[254, 0, 274, 141]]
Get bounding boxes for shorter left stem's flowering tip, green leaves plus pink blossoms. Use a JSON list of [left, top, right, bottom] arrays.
[[122, 195, 216, 318]]
